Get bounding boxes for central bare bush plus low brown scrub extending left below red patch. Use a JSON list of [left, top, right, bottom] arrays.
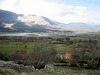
[[8, 44, 56, 69]]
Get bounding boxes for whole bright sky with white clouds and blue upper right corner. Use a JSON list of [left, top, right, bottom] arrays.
[[0, 0, 100, 25]]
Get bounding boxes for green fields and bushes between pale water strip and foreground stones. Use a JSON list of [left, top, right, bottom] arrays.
[[0, 36, 100, 74]]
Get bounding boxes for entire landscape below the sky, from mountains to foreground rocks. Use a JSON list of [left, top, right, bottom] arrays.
[[0, 9, 100, 75]]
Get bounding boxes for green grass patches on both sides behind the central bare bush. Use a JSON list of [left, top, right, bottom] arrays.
[[0, 40, 67, 54]]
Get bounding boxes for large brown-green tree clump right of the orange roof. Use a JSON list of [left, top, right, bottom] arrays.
[[68, 40, 100, 67]]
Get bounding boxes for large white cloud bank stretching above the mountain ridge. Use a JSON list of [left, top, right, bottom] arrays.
[[0, 0, 99, 23]]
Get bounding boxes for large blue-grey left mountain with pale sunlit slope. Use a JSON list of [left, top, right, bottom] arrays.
[[0, 10, 59, 32]]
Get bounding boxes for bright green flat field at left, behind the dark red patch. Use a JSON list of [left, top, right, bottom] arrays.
[[0, 41, 55, 53]]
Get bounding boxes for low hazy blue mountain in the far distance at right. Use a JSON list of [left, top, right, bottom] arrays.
[[60, 22, 100, 31]]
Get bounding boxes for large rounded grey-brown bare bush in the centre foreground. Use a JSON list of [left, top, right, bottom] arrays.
[[30, 44, 57, 69]]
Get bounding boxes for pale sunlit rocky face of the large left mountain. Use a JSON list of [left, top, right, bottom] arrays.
[[18, 15, 54, 25]]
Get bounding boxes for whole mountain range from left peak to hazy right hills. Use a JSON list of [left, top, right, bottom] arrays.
[[0, 10, 100, 32]]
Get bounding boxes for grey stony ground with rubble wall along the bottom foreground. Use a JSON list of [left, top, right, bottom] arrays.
[[0, 61, 100, 75]]
